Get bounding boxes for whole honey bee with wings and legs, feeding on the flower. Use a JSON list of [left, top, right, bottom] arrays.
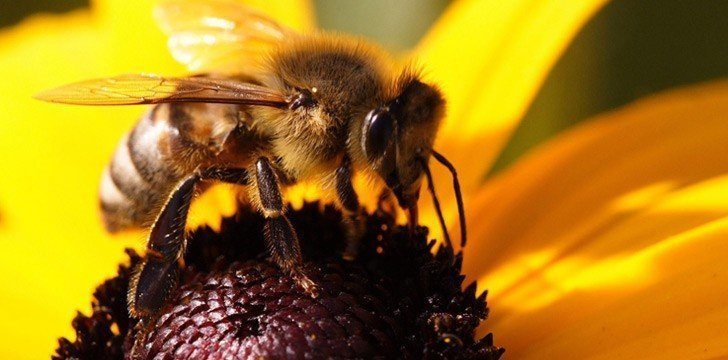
[[37, 0, 465, 317]]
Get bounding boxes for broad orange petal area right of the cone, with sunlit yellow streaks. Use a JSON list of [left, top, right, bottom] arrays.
[[465, 81, 728, 359]]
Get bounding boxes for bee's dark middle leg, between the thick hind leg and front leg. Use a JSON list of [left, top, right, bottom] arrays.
[[255, 157, 319, 297]]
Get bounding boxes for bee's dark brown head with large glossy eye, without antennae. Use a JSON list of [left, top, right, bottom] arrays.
[[361, 75, 445, 222]]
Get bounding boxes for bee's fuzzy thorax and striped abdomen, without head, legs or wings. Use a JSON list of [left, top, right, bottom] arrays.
[[100, 36, 388, 231]]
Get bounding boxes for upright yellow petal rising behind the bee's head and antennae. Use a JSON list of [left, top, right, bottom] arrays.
[[415, 0, 607, 245]]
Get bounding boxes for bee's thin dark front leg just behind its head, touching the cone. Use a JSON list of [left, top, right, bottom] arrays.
[[336, 156, 364, 261]]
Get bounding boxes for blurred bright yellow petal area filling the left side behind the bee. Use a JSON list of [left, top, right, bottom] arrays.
[[0, 1, 311, 359]]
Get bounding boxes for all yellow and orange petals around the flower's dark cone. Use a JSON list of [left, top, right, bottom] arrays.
[[0, 0, 728, 358]]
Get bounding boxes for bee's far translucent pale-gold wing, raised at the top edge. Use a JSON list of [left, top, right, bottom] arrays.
[[154, 0, 294, 73]]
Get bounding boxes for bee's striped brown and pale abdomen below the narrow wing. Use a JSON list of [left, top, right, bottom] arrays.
[[100, 103, 240, 231]]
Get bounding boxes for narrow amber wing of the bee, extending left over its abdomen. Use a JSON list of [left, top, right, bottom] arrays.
[[36, 75, 287, 107]]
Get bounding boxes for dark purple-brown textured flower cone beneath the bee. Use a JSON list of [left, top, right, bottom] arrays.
[[56, 203, 503, 359]]
